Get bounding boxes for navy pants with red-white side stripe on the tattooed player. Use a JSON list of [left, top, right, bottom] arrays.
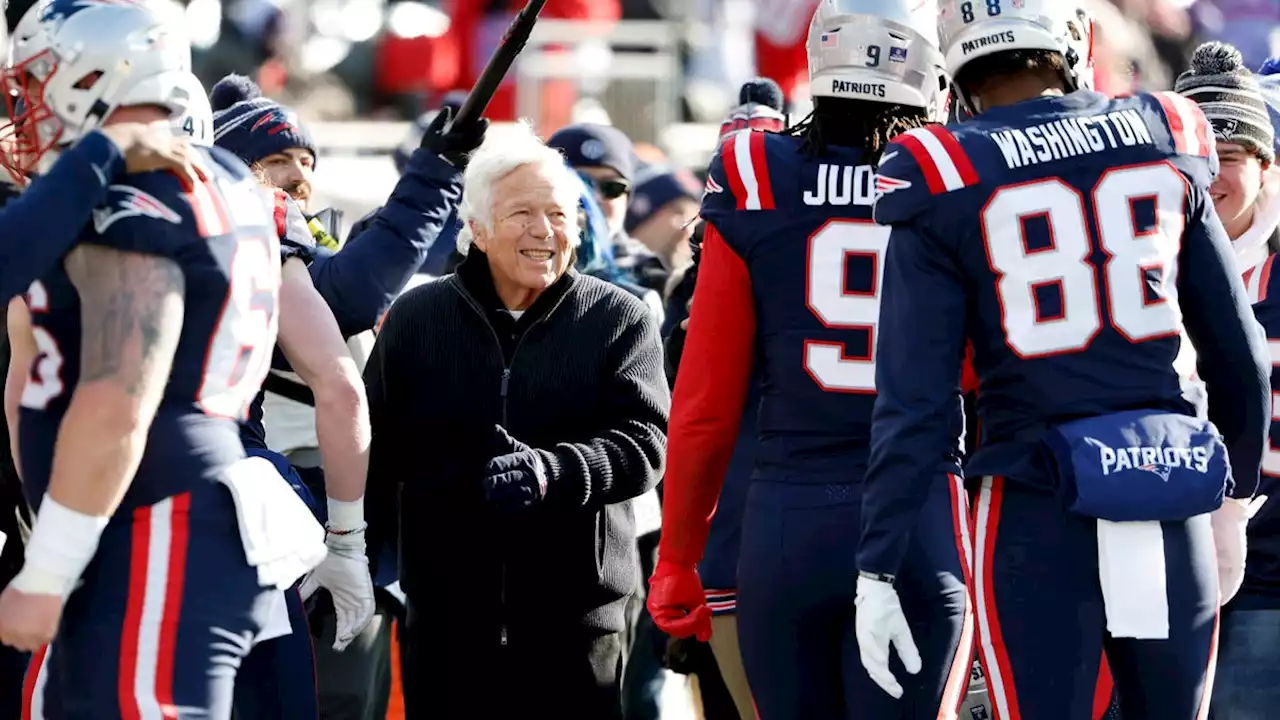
[[24, 483, 270, 720]]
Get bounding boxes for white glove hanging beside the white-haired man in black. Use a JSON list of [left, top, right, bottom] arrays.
[[298, 529, 375, 652]]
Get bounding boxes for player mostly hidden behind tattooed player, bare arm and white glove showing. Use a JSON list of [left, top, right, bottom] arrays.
[[173, 92, 374, 720]]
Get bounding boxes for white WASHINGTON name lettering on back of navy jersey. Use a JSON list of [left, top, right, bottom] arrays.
[[991, 110, 1153, 168]]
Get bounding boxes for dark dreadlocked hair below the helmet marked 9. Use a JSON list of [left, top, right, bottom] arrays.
[[786, 97, 929, 163]]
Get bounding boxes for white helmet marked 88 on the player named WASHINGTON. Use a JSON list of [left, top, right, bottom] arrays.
[[938, 0, 1093, 111]]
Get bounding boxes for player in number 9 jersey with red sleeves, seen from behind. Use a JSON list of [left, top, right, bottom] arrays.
[[649, 0, 972, 720]]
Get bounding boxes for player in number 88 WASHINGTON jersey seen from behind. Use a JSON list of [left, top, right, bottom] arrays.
[[858, 0, 1270, 720]]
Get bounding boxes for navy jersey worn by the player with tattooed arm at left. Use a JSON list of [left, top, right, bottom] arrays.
[[19, 149, 280, 509]]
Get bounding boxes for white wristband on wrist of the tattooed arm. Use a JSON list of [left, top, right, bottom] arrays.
[[9, 493, 110, 597]]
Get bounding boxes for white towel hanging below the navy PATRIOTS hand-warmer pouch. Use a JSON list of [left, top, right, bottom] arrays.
[[1098, 520, 1169, 641]]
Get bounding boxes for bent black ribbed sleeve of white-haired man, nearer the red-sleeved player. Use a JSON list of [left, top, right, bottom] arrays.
[[537, 307, 671, 509]]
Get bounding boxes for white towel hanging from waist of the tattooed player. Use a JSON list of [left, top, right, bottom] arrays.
[[220, 457, 328, 591]]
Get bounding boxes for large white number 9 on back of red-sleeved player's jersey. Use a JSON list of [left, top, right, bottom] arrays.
[[804, 220, 890, 393]]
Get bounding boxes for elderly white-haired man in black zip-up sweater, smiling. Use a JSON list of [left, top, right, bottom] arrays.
[[365, 126, 671, 720]]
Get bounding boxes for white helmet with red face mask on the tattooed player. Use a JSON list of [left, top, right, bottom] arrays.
[[4, 0, 192, 174]]
